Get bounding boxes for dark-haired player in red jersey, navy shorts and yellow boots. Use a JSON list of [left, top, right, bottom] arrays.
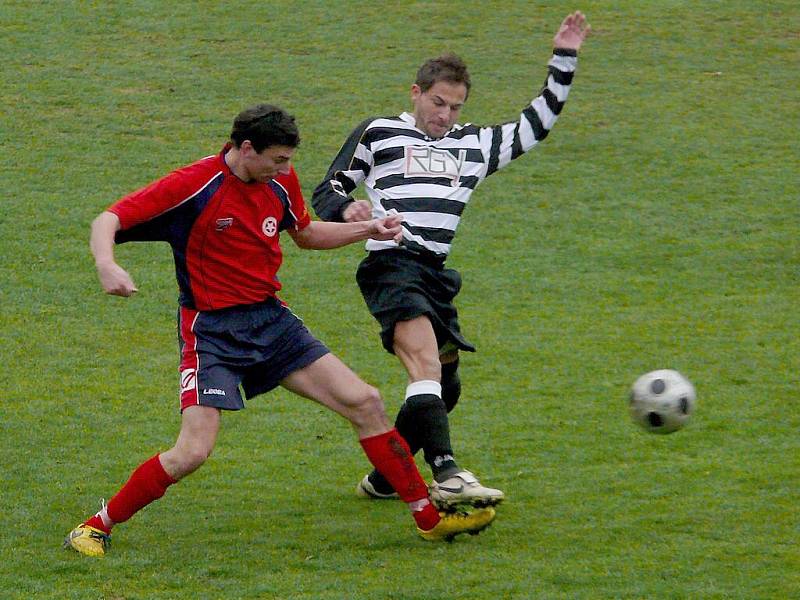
[[65, 104, 495, 556]]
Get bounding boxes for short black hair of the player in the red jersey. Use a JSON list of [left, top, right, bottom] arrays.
[[231, 104, 300, 153]]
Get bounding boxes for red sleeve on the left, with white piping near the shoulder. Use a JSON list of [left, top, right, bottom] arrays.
[[107, 166, 211, 230]]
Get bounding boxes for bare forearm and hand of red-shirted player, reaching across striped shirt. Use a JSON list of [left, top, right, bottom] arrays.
[[289, 215, 403, 250]]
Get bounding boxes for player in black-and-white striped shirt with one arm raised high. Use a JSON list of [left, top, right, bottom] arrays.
[[312, 12, 590, 508]]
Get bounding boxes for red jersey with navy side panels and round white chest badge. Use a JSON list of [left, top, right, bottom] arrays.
[[108, 145, 311, 310]]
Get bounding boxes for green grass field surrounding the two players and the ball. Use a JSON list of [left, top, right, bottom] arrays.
[[0, 0, 800, 600]]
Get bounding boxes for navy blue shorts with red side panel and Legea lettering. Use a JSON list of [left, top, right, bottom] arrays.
[[178, 298, 330, 410]]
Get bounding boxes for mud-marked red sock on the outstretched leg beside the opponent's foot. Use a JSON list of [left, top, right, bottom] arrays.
[[360, 429, 440, 531]]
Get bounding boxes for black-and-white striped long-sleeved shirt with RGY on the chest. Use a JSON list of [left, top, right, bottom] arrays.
[[312, 49, 578, 258]]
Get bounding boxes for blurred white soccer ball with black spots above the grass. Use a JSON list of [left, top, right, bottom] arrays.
[[630, 369, 697, 433]]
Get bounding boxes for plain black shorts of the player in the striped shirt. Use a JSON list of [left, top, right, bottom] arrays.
[[356, 250, 475, 354]]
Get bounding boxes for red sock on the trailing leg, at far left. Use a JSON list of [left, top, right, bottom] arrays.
[[86, 454, 175, 533]]
